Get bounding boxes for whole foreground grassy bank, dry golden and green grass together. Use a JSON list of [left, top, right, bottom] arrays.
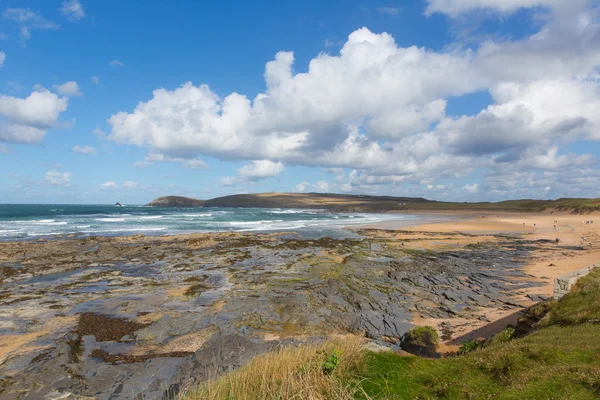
[[180, 269, 600, 400]]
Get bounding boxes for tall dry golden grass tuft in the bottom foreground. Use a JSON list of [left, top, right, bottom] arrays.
[[180, 336, 365, 400]]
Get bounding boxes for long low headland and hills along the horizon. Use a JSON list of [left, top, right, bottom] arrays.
[[147, 193, 600, 214]]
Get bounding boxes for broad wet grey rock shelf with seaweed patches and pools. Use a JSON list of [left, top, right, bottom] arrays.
[[0, 231, 556, 399]]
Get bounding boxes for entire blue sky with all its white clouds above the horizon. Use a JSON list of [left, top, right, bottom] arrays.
[[0, 0, 600, 204]]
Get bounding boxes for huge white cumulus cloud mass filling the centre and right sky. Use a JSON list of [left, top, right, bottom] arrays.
[[108, 0, 600, 198]]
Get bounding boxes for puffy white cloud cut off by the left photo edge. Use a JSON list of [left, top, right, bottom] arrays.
[[0, 89, 68, 144]]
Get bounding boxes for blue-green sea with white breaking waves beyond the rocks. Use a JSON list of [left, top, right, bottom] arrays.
[[0, 204, 420, 241]]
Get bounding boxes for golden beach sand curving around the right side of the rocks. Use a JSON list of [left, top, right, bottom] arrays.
[[366, 211, 600, 352]]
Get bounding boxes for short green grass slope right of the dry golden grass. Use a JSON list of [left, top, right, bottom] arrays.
[[358, 324, 600, 399]]
